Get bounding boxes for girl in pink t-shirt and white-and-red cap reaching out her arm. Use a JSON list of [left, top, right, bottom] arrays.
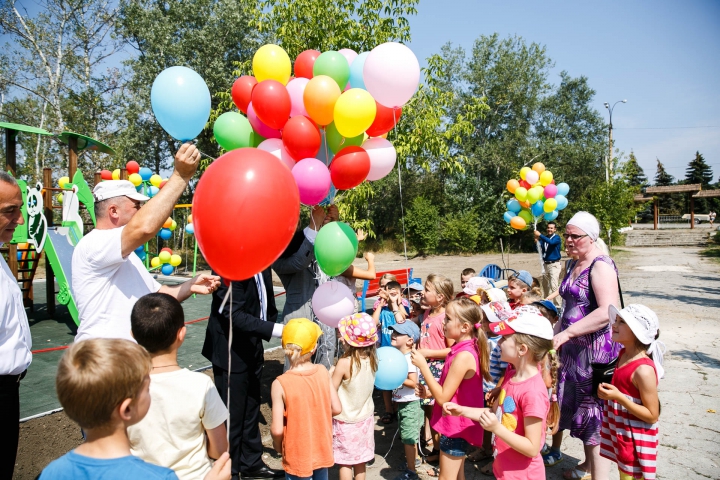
[[443, 310, 559, 480]]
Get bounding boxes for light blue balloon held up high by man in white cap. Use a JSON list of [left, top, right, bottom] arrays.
[[150, 67, 210, 142]]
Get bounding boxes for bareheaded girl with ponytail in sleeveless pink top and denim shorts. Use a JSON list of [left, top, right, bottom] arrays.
[[412, 298, 491, 480]]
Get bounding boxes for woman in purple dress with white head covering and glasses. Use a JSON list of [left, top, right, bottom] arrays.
[[553, 212, 620, 480]]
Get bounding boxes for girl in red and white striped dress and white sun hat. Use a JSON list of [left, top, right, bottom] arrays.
[[598, 304, 665, 480]]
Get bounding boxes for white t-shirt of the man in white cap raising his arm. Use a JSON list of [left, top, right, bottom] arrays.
[[72, 227, 161, 342]]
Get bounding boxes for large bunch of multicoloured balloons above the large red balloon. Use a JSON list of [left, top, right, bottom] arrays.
[[213, 42, 420, 205]]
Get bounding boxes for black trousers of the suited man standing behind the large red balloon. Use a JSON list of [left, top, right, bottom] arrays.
[[213, 360, 264, 476]]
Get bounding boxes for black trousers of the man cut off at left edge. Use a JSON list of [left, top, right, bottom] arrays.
[[0, 375, 20, 479]]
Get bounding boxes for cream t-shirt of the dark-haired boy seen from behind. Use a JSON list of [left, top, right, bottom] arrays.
[[128, 368, 227, 480]]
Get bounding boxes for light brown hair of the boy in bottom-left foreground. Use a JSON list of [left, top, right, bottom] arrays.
[[55, 338, 152, 429]]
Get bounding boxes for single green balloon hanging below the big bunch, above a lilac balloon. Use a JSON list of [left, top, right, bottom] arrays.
[[315, 222, 357, 277]]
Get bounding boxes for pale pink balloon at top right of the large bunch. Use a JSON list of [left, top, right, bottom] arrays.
[[363, 42, 420, 108]]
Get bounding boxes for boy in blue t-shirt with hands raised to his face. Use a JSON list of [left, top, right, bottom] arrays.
[[373, 281, 410, 425]]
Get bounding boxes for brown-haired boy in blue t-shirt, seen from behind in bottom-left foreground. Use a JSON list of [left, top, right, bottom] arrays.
[[40, 338, 230, 480]]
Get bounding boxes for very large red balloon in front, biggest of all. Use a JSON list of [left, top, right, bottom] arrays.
[[192, 148, 300, 281]]
